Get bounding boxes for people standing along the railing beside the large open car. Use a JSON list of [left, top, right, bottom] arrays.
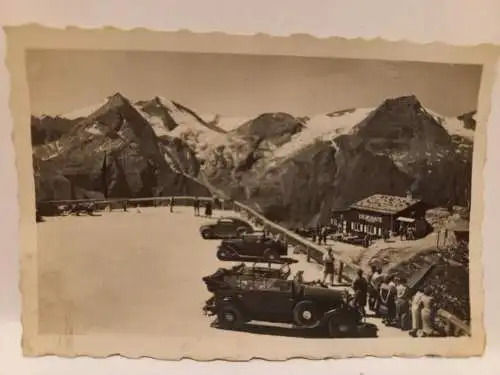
[[321, 251, 436, 337]]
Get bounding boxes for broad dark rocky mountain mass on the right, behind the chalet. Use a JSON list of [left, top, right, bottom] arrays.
[[203, 96, 472, 225]]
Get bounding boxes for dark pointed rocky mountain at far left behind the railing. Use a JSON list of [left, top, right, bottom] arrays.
[[34, 94, 209, 200]]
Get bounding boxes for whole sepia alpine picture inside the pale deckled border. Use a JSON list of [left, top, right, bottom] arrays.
[[8, 28, 496, 359]]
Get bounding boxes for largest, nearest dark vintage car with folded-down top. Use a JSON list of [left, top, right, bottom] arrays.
[[203, 269, 363, 337]]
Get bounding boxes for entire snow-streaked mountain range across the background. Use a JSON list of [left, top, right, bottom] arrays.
[[31, 93, 475, 225]]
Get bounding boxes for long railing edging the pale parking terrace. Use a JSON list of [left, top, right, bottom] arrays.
[[37, 196, 471, 336]]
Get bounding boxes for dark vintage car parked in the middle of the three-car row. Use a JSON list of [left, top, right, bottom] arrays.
[[217, 232, 288, 261]]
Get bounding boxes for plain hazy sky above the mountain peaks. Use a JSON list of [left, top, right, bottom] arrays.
[[26, 50, 481, 116]]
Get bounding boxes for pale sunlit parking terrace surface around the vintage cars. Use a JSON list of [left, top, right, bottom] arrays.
[[38, 207, 407, 356]]
